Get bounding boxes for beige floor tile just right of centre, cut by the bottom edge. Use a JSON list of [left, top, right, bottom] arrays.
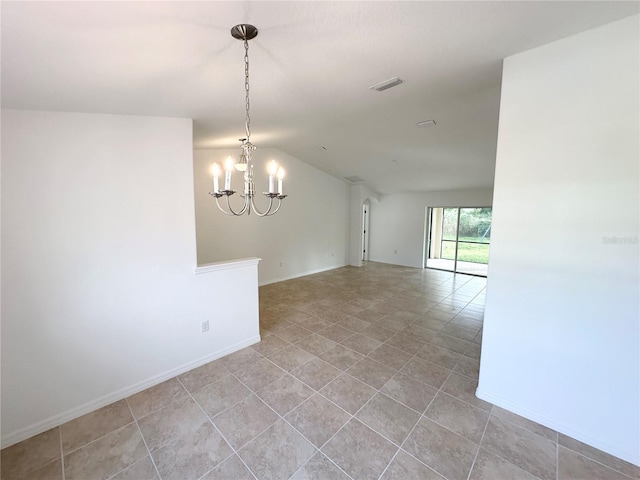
[[322, 419, 398, 479]]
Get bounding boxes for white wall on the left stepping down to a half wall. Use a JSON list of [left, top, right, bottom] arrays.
[[2, 110, 259, 446]]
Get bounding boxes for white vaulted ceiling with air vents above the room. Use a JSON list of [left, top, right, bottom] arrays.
[[1, 1, 639, 193]]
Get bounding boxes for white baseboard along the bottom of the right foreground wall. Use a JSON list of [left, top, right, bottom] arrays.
[[476, 388, 640, 466]]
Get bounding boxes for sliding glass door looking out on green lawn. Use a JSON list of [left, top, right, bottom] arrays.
[[424, 207, 491, 277]]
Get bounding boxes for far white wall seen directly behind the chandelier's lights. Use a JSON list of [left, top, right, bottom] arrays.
[[194, 148, 349, 285]]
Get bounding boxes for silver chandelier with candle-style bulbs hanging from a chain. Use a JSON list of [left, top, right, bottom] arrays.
[[209, 24, 286, 217]]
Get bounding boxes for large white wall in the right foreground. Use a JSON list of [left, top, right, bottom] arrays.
[[478, 16, 640, 464]]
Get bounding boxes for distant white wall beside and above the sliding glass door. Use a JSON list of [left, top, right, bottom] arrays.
[[369, 189, 493, 268]]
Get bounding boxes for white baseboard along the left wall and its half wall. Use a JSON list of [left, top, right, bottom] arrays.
[[1, 335, 260, 448]]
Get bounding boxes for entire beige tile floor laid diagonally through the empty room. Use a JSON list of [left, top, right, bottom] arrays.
[[2, 263, 640, 480]]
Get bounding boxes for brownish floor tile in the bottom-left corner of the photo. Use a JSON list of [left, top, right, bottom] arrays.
[[0, 428, 61, 480]]
